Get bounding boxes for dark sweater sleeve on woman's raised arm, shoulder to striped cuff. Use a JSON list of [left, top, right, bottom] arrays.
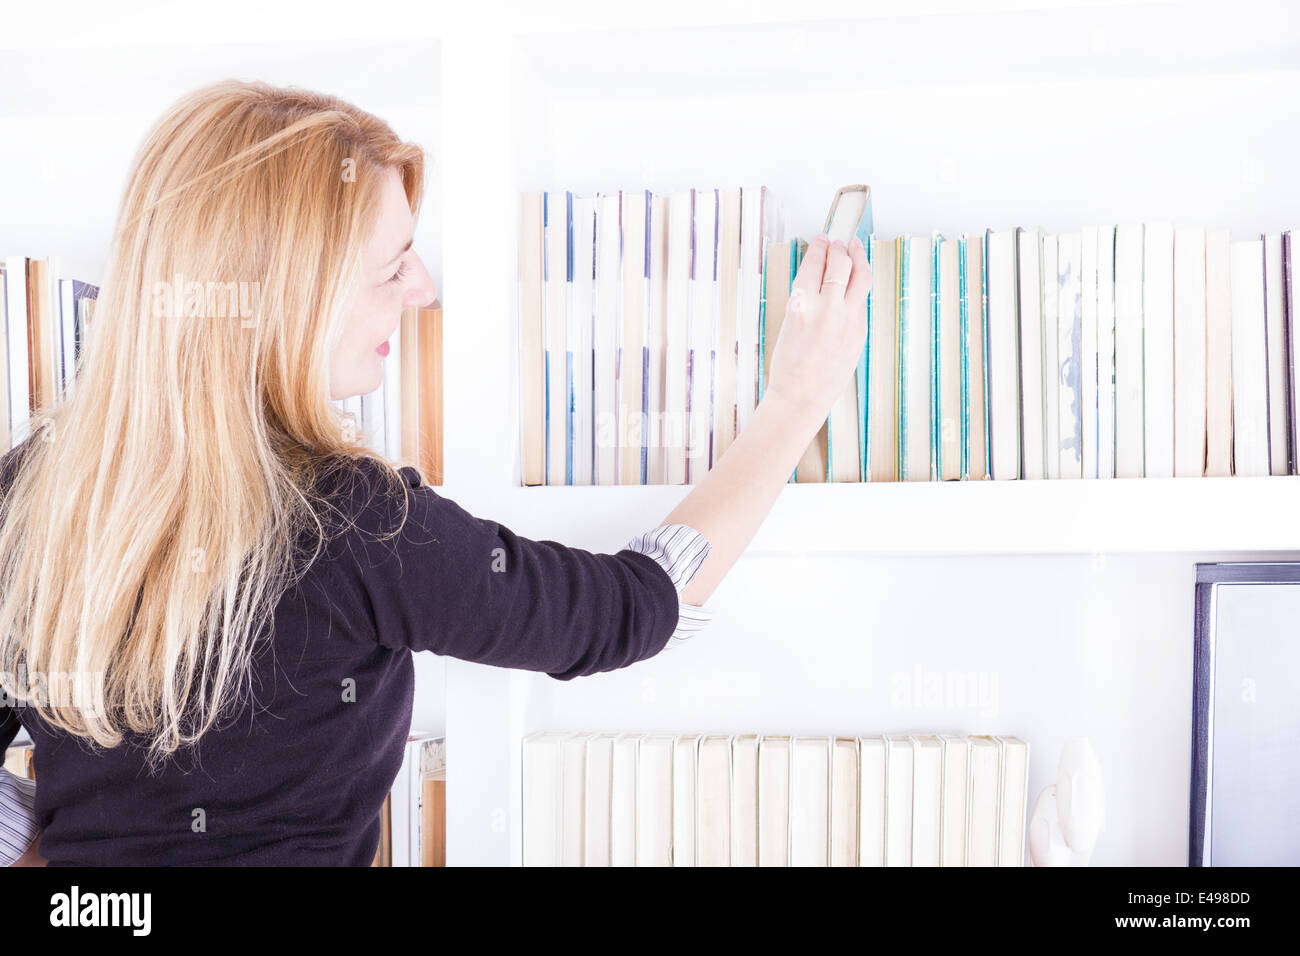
[[326, 466, 679, 680]]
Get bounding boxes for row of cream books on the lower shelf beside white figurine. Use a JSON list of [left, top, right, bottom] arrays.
[[523, 731, 1030, 866]]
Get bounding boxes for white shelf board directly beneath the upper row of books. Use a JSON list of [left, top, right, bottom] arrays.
[[478, 476, 1300, 555]]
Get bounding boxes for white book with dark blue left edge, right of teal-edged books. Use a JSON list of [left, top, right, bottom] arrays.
[[987, 232, 1021, 481]]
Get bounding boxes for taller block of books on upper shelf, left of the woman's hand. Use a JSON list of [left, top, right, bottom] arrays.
[[519, 186, 781, 485]]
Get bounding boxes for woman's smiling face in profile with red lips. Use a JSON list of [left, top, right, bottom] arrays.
[[330, 169, 437, 399]]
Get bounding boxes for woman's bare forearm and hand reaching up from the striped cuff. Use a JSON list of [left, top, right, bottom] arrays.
[[663, 235, 871, 605]]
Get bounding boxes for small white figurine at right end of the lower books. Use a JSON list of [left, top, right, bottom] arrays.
[[1030, 737, 1105, 866]]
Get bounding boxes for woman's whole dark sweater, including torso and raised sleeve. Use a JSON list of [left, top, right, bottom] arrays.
[[0, 453, 679, 866]]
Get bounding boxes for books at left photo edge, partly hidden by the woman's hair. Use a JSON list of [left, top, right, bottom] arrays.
[[0, 256, 99, 450]]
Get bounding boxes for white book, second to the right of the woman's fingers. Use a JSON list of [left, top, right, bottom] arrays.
[[900, 235, 933, 481]]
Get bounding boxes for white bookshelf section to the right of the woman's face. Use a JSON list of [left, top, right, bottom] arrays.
[[443, 3, 1300, 865]]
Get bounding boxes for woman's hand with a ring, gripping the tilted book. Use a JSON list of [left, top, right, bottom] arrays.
[[763, 235, 872, 418]]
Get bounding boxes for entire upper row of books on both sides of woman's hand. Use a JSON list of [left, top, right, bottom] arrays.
[[520, 187, 1300, 485]]
